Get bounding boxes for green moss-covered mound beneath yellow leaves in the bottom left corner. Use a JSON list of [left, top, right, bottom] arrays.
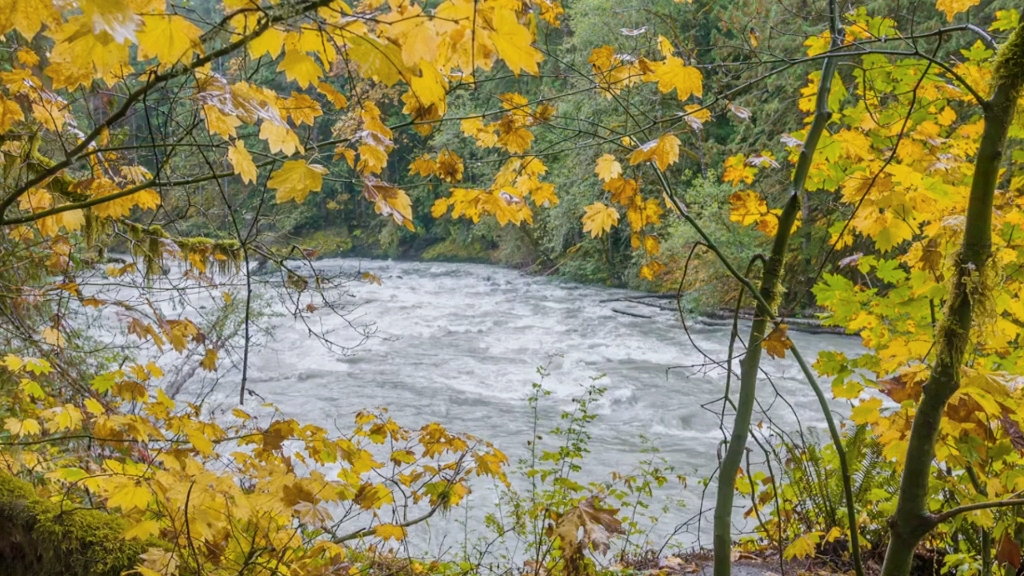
[[0, 474, 154, 576]]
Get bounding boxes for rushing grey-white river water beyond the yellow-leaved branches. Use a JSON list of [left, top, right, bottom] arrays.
[[186, 259, 860, 545]]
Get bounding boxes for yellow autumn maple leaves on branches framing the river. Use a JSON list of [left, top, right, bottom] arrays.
[[0, 0, 1024, 576]]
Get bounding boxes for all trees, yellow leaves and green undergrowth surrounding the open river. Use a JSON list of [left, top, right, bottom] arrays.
[[0, 0, 1024, 576]]
